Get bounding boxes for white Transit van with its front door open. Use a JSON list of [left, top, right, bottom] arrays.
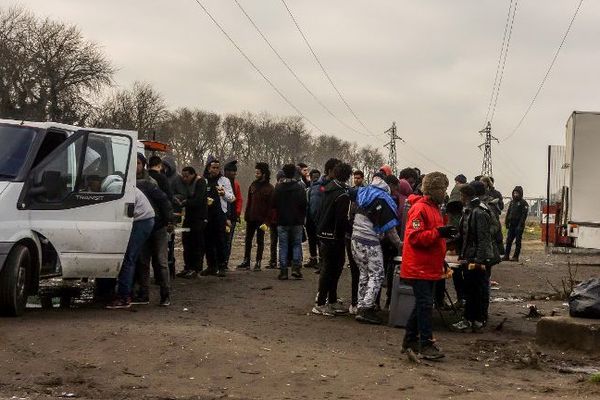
[[0, 119, 139, 316]]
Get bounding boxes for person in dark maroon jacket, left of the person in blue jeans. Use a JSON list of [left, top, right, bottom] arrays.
[[237, 162, 274, 271]]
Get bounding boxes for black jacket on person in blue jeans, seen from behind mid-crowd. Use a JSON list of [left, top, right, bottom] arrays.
[[272, 179, 307, 226]]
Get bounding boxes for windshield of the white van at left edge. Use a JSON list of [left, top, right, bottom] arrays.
[[0, 125, 35, 181]]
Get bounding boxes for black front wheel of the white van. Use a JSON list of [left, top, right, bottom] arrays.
[[0, 244, 31, 317]]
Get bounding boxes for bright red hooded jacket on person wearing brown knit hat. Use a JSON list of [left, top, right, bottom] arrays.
[[400, 195, 446, 281]]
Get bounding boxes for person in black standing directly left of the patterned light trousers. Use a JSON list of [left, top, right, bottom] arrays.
[[312, 163, 352, 316]]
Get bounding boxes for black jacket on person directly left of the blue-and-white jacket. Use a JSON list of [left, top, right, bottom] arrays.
[[317, 180, 350, 240]]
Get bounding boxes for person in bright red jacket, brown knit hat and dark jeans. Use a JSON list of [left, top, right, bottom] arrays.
[[400, 172, 457, 360]]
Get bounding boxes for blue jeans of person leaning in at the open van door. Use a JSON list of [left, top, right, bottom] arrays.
[[117, 218, 154, 298]]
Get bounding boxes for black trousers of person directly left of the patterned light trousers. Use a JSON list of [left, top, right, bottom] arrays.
[[317, 240, 346, 306]]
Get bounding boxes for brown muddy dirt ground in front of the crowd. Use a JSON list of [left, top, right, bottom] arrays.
[[0, 231, 600, 399]]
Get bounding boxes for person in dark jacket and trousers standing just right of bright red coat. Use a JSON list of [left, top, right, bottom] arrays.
[[452, 182, 500, 332]]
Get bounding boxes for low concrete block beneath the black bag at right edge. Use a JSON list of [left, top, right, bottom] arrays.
[[536, 317, 600, 354]]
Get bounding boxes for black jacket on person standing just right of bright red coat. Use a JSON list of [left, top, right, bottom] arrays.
[[459, 198, 500, 265]]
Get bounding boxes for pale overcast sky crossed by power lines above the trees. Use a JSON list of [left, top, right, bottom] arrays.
[[8, 0, 600, 196]]
